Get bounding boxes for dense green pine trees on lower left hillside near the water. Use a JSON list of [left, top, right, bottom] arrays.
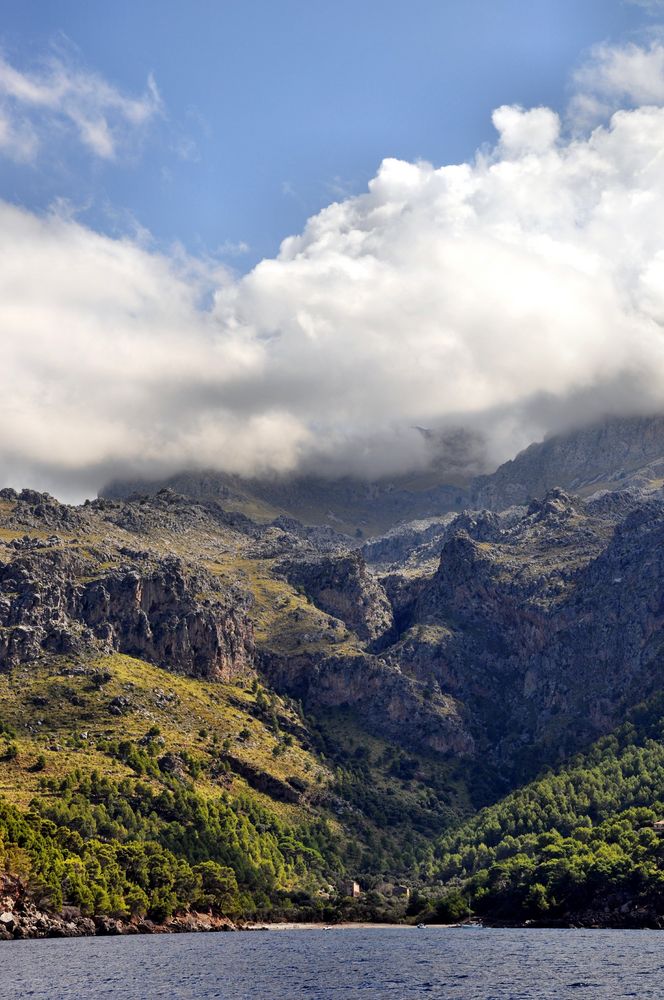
[[0, 772, 340, 920]]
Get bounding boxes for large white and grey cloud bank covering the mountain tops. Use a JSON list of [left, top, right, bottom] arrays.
[[0, 43, 664, 495]]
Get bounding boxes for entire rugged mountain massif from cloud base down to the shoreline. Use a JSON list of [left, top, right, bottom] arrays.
[[0, 418, 664, 936]]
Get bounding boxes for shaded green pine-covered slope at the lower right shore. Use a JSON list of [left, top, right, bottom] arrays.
[[436, 695, 664, 920]]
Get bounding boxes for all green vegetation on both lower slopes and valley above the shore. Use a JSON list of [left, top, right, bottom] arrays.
[[7, 656, 664, 922]]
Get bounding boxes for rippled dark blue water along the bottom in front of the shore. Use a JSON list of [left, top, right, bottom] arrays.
[[0, 928, 664, 1000]]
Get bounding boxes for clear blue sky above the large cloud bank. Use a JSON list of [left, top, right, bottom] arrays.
[[0, 0, 653, 270]]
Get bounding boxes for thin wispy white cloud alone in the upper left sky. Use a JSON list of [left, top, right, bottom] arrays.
[[0, 50, 161, 162]]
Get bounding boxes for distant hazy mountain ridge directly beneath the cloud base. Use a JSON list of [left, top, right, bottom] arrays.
[[100, 415, 664, 538]]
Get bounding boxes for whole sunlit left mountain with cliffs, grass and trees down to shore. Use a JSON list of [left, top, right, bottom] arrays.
[[0, 490, 480, 936]]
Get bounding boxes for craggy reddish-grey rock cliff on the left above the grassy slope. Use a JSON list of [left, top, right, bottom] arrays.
[[0, 549, 253, 680]]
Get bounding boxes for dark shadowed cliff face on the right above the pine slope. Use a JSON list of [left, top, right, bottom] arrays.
[[370, 490, 664, 766]]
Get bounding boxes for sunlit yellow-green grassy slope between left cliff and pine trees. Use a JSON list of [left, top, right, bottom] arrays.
[[0, 655, 331, 820]]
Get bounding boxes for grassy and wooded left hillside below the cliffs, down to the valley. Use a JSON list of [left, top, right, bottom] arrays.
[[0, 655, 473, 921]]
